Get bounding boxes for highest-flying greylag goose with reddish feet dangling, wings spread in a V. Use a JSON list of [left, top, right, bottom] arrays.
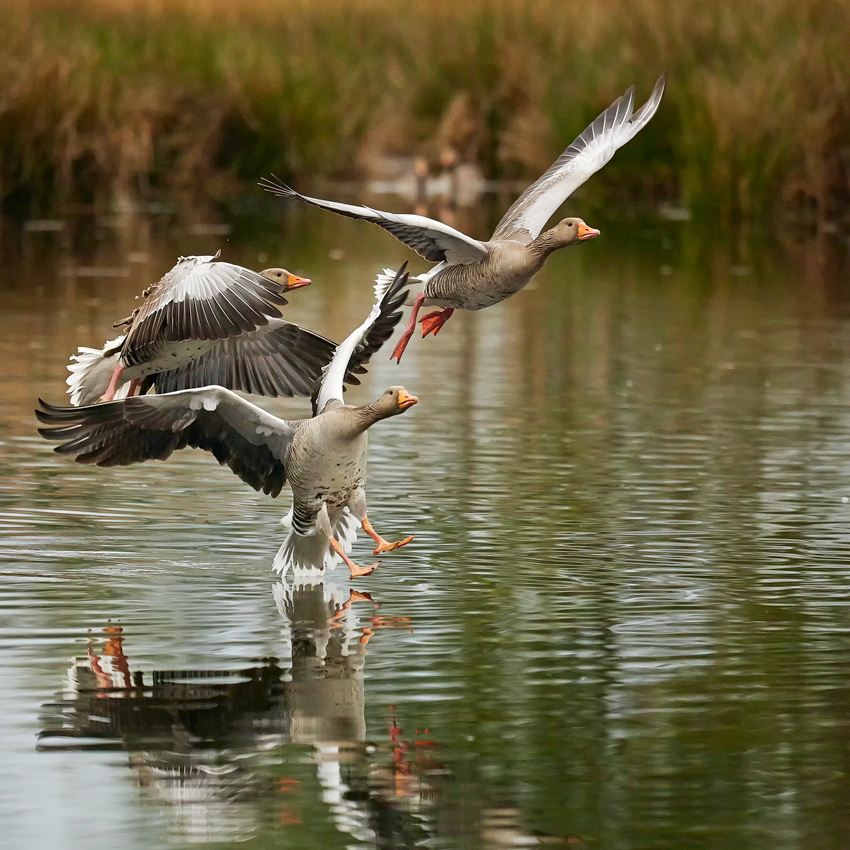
[[261, 75, 666, 361]]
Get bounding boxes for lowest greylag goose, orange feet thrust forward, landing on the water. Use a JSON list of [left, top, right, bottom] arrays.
[[36, 267, 418, 578]]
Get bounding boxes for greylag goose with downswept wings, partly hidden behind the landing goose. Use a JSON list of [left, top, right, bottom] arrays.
[[67, 252, 352, 406]]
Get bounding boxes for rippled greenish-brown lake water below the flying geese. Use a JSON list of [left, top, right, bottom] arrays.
[[0, 204, 850, 850]]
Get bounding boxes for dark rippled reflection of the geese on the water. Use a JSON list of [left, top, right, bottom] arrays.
[[39, 576, 562, 850]]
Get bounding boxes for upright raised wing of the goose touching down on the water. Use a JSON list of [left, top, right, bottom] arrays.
[[312, 263, 407, 416]]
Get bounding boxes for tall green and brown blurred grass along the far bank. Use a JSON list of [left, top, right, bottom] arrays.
[[0, 0, 850, 219]]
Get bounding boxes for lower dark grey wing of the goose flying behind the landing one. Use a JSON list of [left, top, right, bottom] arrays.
[[140, 319, 366, 398]]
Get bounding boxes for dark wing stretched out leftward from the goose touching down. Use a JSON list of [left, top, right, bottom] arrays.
[[36, 387, 298, 497]]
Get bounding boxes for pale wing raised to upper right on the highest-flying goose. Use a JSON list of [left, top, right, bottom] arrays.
[[493, 74, 667, 244]]
